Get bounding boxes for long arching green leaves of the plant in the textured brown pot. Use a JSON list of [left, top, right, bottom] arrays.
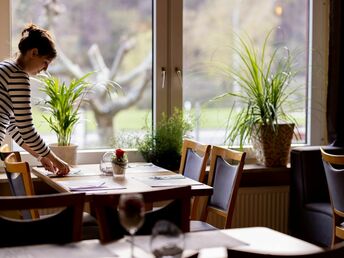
[[215, 31, 297, 148]]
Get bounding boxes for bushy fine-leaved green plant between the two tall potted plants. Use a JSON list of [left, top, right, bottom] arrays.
[[137, 109, 192, 171]]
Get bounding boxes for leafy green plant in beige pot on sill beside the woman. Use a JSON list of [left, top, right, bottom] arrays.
[[38, 73, 92, 165]]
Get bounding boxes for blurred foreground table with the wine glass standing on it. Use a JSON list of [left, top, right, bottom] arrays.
[[0, 227, 323, 258]]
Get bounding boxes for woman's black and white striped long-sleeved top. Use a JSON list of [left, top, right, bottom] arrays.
[[0, 61, 50, 156]]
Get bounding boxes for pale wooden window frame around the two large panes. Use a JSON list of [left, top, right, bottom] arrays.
[[0, 0, 330, 164]]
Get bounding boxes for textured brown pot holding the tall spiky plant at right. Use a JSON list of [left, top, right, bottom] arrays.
[[251, 124, 295, 167]]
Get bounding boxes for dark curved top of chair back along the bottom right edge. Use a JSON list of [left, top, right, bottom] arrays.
[[227, 243, 344, 258]]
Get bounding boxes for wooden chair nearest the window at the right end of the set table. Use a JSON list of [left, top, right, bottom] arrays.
[[179, 139, 211, 219]]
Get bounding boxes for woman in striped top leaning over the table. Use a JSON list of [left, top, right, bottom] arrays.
[[0, 24, 69, 176]]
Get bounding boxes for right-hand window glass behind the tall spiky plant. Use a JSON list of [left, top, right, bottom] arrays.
[[183, 0, 309, 145]]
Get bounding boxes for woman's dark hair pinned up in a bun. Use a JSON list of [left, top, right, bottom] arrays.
[[18, 24, 56, 59]]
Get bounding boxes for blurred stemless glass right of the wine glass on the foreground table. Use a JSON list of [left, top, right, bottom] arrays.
[[151, 220, 184, 258]]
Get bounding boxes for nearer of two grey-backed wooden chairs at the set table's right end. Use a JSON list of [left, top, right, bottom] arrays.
[[190, 146, 246, 231]]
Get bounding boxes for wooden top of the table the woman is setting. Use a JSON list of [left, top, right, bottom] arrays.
[[32, 163, 213, 196]]
